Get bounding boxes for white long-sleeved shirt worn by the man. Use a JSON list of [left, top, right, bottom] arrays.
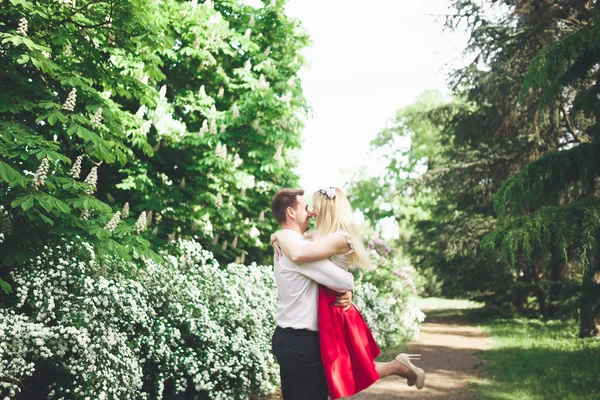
[[275, 229, 354, 331]]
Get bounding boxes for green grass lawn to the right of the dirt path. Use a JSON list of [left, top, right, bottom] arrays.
[[475, 319, 600, 400]]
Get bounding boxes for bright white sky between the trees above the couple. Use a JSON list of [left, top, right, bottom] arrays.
[[286, 0, 466, 193]]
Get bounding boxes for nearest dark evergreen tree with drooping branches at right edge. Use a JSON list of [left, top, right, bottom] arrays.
[[484, 2, 600, 337]]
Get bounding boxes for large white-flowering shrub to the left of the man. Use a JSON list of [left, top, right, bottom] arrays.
[[0, 241, 278, 399]]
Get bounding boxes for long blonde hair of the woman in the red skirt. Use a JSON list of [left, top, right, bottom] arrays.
[[313, 188, 371, 269]]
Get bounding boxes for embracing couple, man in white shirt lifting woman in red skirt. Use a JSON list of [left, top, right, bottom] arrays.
[[271, 187, 425, 400]]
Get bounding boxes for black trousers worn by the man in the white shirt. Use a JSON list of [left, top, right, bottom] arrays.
[[271, 326, 328, 400]]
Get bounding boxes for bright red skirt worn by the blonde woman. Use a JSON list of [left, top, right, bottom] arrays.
[[319, 286, 380, 400]]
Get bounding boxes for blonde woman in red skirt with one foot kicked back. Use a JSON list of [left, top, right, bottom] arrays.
[[271, 187, 425, 399]]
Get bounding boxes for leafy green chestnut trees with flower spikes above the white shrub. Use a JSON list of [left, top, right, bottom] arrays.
[[0, 0, 307, 294]]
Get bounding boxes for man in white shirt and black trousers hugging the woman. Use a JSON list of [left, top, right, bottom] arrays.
[[271, 189, 354, 400]]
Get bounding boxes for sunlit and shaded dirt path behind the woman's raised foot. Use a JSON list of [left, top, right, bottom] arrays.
[[346, 309, 491, 400]]
